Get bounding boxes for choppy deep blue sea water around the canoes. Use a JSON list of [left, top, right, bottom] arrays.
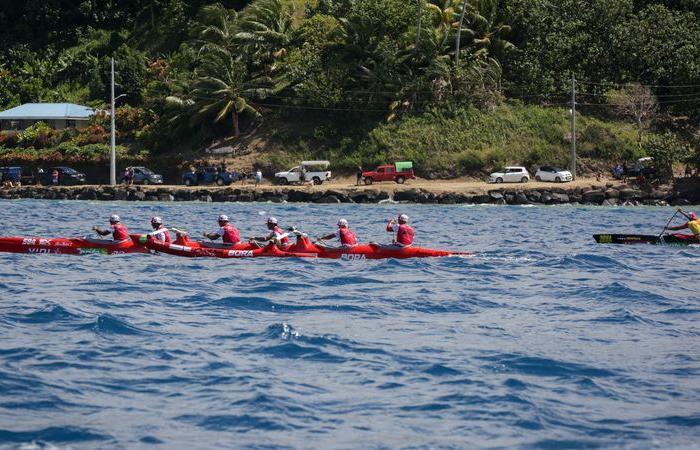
[[0, 200, 700, 449]]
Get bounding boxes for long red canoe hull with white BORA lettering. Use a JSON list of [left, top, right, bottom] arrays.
[[146, 236, 471, 259]]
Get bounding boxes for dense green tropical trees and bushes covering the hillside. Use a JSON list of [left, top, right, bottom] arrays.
[[0, 0, 700, 176]]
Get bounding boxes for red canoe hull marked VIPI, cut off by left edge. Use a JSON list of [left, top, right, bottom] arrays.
[[0, 234, 148, 255]]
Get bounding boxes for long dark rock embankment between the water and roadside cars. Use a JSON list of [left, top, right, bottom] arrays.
[[0, 184, 698, 206]]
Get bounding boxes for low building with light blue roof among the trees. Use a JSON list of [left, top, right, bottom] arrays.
[[0, 103, 95, 131]]
